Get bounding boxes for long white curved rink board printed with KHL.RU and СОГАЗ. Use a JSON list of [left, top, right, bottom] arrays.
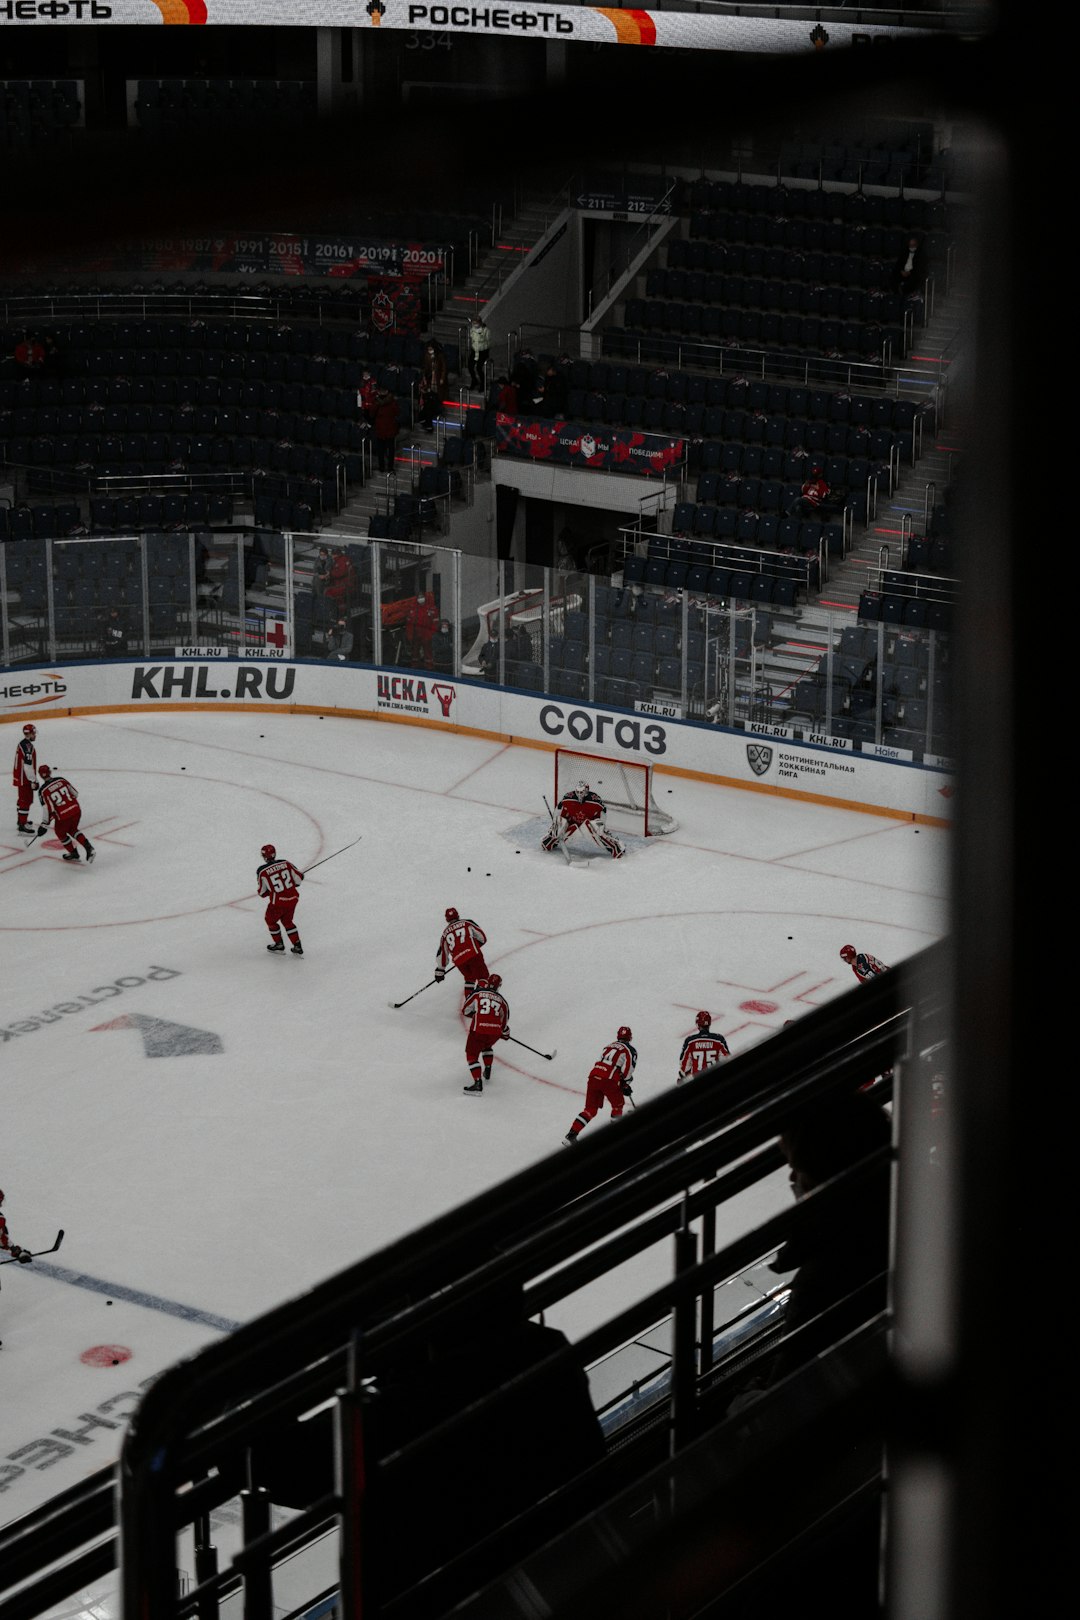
[[0, 659, 955, 826]]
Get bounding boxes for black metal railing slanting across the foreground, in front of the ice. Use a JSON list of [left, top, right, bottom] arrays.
[[0, 946, 944, 1620]]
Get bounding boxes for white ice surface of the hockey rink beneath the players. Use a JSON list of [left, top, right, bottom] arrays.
[[0, 711, 949, 1523]]
